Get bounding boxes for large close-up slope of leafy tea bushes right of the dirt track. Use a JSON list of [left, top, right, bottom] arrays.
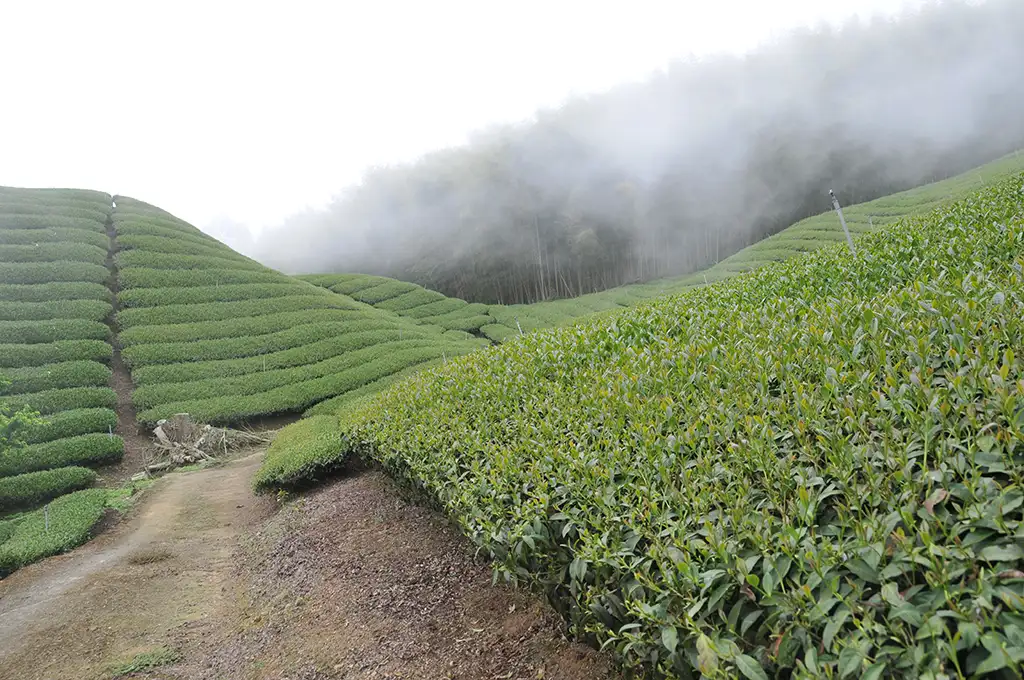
[[256, 175, 1024, 679]]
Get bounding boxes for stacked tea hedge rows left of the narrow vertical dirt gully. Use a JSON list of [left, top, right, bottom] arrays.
[[0, 187, 124, 575]]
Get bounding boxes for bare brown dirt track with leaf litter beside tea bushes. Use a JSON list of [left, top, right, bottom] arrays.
[[0, 453, 611, 680]]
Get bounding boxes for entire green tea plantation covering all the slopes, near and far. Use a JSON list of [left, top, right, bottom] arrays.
[[0, 157, 1024, 678]]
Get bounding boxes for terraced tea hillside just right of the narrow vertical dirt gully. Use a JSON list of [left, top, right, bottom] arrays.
[[114, 197, 483, 423]]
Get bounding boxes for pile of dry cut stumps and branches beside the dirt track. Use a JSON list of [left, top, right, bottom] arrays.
[[146, 414, 270, 472]]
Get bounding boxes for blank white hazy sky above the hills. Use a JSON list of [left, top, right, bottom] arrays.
[[0, 0, 922, 244]]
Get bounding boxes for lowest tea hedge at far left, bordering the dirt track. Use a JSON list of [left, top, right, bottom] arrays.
[[0, 488, 110, 576]]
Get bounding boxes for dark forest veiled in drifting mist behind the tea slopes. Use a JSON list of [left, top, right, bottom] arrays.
[[256, 0, 1024, 303]]
